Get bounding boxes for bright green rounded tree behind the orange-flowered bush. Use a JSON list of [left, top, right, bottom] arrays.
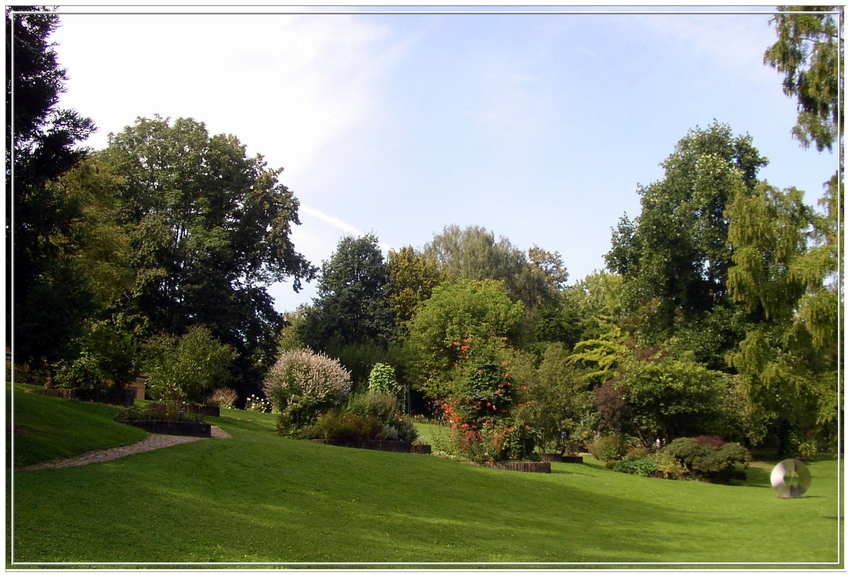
[[405, 279, 523, 399]]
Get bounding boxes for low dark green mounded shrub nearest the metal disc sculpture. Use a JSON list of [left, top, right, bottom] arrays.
[[660, 437, 750, 483]]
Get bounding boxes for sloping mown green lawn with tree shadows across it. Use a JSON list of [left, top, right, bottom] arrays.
[[7, 384, 840, 568]]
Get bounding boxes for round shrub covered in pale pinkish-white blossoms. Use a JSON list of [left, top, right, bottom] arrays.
[[263, 349, 351, 433]]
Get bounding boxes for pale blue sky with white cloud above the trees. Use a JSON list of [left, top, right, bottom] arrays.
[[52, 6, 838, 312]]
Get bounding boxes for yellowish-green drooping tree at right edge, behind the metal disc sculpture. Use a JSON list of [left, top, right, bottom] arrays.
[[729, 183, 840, 453]]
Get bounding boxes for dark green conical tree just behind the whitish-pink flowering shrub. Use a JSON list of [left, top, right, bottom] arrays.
[[302, 234, 393, 351]]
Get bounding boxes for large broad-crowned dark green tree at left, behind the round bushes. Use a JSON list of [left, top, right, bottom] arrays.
[[97, 116, 315, 397]]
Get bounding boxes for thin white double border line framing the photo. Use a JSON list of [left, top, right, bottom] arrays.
[[7, 5, 844, 566]]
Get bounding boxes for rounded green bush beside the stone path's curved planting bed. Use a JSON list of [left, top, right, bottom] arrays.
[[145, 326, 233, 417]]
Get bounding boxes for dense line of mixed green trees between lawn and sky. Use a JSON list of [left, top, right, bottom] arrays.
[[7, 8, 843, 455]]
